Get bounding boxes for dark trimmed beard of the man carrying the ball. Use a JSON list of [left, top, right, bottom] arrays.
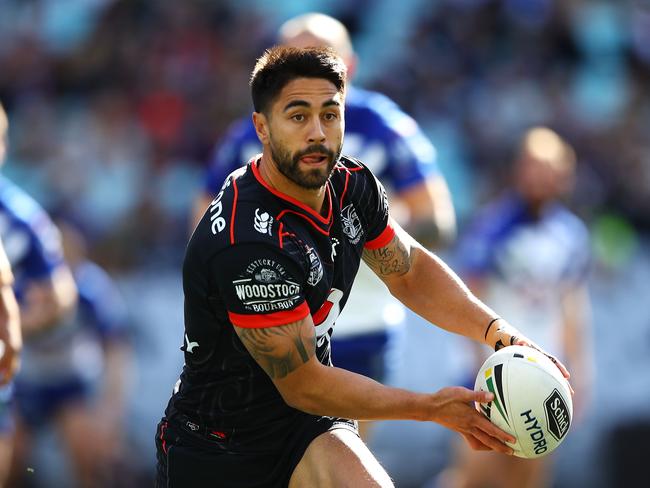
[[270, 139, 342, 190]]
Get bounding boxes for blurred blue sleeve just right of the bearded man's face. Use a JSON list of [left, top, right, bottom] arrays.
[[360, 94, 440, 193]]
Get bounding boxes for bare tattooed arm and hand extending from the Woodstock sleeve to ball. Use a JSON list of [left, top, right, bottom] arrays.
[[235, 316, 512, 453]]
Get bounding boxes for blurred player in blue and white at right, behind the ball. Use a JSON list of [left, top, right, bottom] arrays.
[[437, 127, 592, 488]]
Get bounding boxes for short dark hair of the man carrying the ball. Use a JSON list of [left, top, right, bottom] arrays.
[[250, 46, 347, 112]]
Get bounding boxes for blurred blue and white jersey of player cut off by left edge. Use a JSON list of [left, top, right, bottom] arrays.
[[0, 175, 63, 303]]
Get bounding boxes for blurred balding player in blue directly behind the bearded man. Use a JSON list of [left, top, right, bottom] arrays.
[[194, 13, 456, 439]]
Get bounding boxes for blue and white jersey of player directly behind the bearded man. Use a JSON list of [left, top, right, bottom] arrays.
[[204, 87, 439, 338]]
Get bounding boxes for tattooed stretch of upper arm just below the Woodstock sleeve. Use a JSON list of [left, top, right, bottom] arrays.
[[235, 321, 316, 379]]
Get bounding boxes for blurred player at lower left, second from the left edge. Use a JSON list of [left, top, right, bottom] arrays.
[[11, 219, 133, 487]]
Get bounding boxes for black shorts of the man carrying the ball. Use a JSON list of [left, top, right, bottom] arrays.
[[156, 416, 357, 488]]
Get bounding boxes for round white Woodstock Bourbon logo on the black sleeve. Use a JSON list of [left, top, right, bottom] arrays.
[[233, 258, 302, 313]]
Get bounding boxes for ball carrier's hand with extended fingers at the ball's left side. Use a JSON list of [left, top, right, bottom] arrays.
[[433, 386, 516, 455]]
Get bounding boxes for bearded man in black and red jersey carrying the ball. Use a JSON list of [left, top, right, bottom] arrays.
[[156, 47, 568, 487]]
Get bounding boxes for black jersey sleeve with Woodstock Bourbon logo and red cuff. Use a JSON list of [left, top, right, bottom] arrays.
[[211, 243, 310, 328]]
